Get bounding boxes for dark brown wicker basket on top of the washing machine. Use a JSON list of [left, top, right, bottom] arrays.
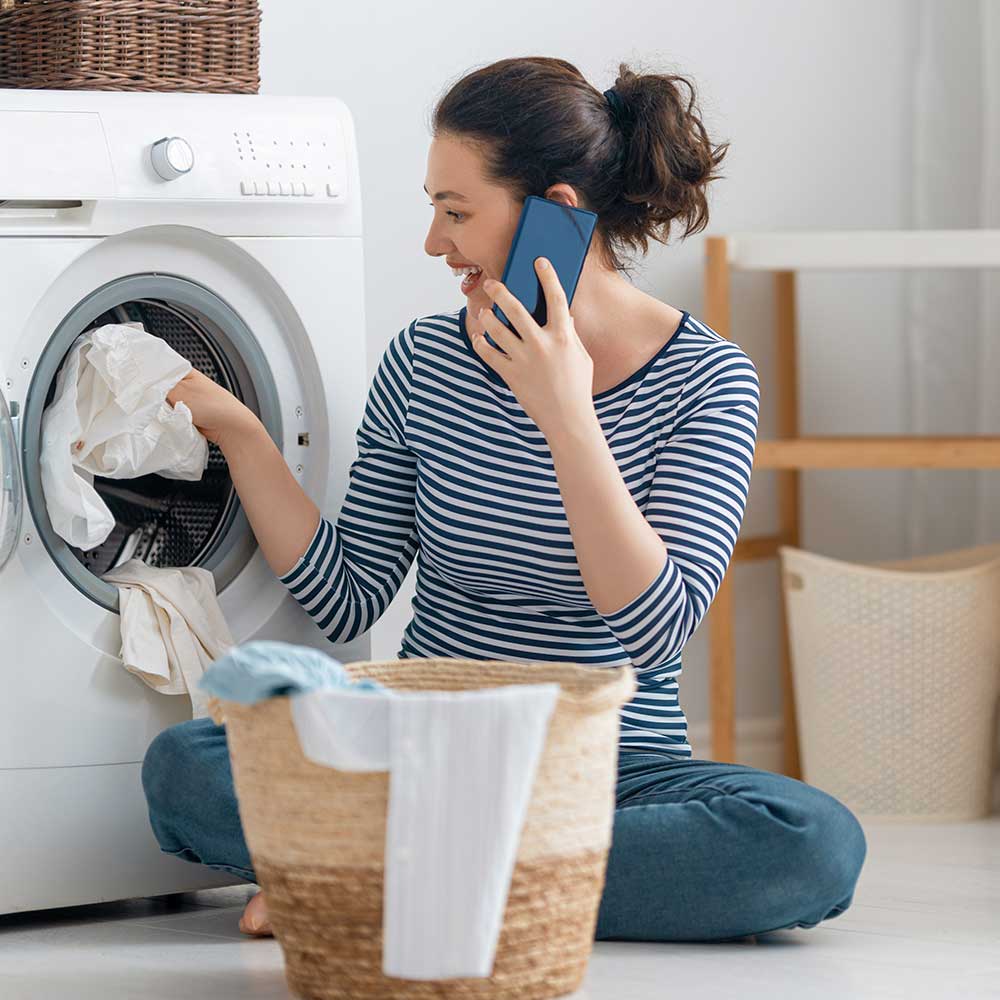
[[0, 0, 260, 94]]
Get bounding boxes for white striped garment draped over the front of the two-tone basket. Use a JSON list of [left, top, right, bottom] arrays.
[[291, 684, 559, 979]]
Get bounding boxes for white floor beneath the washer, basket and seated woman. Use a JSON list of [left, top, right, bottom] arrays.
[[0, 815, 1000, 1000]]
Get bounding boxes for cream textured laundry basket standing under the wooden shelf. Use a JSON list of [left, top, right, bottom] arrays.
[[779, 544, 1000, 822]]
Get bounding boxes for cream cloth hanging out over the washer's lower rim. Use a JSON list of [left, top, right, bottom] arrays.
[[101, 559, 233, 719]]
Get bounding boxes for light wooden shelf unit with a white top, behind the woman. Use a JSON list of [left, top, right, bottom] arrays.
[[705, 229, 1000, 779]]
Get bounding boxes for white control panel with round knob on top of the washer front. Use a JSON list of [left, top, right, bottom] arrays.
[[0, 89, 360, 214]]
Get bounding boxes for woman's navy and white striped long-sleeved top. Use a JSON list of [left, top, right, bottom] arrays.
[[281, 300, 760, 757]]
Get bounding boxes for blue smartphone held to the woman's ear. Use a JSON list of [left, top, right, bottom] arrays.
[[486, 194, 597, 347]]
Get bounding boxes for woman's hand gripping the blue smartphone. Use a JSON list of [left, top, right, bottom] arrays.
[[470, 257, 594, 437]]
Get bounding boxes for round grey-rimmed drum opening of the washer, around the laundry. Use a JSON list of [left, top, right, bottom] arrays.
[[21, 274, 281, 611]]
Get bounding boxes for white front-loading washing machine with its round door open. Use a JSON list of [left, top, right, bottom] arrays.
[[0, 90, 369, 913]]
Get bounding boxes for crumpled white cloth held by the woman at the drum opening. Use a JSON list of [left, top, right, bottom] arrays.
[[39, 323, 208, 550]]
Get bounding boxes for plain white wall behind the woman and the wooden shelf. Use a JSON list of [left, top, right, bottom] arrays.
[[262, 0, 968, 755]]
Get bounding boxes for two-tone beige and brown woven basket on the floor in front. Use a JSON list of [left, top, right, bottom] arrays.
[[213, 659, 635, 1000]]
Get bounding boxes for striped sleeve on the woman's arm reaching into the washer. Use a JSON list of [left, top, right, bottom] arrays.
[[278, 323, 418, 642]]
